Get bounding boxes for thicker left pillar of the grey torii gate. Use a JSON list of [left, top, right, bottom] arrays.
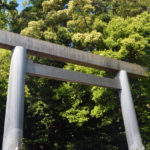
[[2, 46, 26, 150]]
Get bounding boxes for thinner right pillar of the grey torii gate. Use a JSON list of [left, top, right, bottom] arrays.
[[118, 70, 144, 150]]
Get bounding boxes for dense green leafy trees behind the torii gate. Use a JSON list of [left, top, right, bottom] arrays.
[[0, 0, 150, 150]]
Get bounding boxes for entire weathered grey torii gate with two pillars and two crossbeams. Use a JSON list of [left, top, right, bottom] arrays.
[[0, 30, 148, 150]]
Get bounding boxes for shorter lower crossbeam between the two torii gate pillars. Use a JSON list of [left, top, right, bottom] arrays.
[[26, 61, 121, 90]]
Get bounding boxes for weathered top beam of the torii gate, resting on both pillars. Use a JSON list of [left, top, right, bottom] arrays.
[[0, 30, 148, 77]]
